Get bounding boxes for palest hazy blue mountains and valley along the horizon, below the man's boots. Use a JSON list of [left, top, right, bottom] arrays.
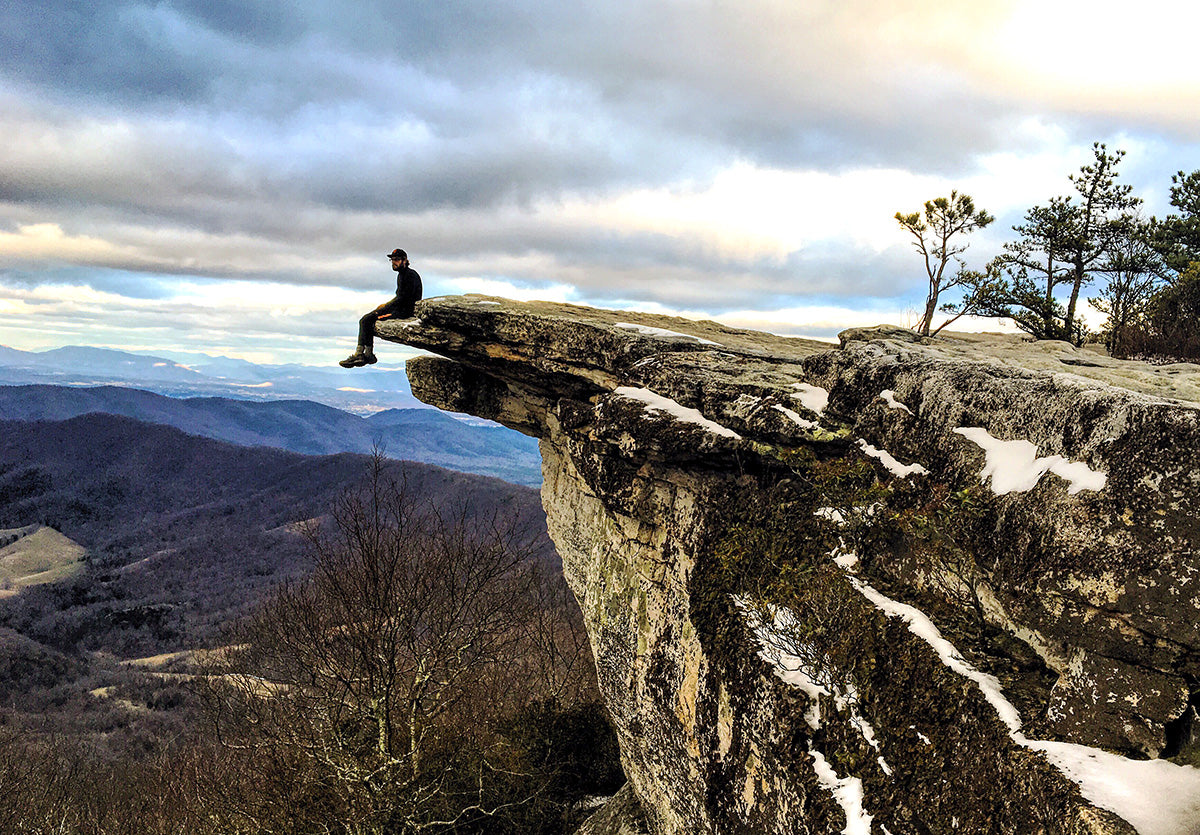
[[0, 346, 428, 414]]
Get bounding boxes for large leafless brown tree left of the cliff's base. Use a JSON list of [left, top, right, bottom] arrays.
[[205, 456, 592, 834]]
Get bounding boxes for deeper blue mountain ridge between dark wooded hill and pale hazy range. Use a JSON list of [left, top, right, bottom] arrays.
[[0, 386, 541, 486]]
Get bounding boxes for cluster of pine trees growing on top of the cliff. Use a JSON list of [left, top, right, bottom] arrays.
[[895, 143, 1200, 361]]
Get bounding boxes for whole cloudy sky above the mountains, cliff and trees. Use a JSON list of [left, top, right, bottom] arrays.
[[0, 0, 1200, 364]]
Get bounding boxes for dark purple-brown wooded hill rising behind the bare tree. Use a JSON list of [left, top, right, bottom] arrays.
[[0, 414, 554, 656]]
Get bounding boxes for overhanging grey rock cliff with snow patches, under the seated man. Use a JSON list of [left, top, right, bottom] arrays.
[[379, 296, 1200, 835]]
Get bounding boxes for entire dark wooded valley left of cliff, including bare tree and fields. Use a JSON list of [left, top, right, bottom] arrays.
[[0, 414, 623, 833]]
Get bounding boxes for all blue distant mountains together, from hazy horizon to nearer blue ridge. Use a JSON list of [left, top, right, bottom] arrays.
[[0, 346, 541, 486]]
